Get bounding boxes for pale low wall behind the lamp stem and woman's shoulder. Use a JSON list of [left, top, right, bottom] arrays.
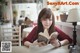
[[56, 22, 80, 45]]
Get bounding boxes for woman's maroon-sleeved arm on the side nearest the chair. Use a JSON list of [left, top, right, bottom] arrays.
[[23, 27, 37, 45]]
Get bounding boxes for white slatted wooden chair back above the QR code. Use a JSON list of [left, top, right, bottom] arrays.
[[2, 26, 21, 46]]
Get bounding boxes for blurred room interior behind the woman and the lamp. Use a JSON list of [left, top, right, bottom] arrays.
[[0, 0, 80, 46]]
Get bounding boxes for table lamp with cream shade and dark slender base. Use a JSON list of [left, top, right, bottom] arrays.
[[66, 8, 80, 52]]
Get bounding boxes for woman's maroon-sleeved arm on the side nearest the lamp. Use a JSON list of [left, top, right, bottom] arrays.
[[55, 26, 73, 45]]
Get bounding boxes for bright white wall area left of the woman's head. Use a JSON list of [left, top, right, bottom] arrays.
[[13, 3, 38, 24]]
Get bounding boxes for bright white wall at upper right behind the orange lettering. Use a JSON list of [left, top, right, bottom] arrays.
[[48, 0, 80, 22]]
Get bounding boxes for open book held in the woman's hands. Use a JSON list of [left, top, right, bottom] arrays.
[[38, 29, 58, 44]]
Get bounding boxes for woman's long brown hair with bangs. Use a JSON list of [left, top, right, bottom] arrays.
[[37, 8, 55, 34]]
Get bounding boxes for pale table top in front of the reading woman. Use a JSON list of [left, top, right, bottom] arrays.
[[0, 45, 69, 53]]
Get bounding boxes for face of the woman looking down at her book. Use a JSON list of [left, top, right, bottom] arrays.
[[41, 16, 52, 29]]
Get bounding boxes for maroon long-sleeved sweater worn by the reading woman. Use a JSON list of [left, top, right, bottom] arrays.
[[23, 26, 72, 43]]
